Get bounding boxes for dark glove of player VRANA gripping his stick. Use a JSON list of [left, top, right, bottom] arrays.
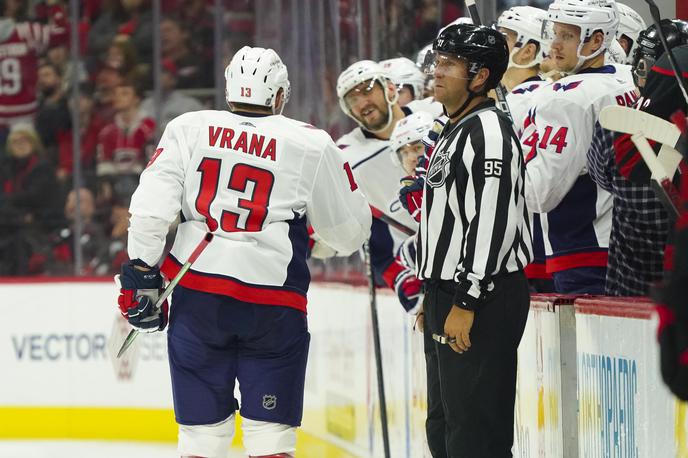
[[115, 261, 169, 332]]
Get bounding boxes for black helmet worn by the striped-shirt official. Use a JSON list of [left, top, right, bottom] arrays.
[[432, 24, 509, 92]]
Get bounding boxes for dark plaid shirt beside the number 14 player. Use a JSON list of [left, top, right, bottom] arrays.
[[588, 123, 669, 296]]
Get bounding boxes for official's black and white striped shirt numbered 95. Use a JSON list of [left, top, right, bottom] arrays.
[[417, 100, 533, 309]]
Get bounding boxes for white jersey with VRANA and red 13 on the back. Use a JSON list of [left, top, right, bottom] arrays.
[[128, 110, 371, 310]]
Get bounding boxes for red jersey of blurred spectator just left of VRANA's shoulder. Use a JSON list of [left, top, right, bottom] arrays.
[[96, 114, 155, 175]]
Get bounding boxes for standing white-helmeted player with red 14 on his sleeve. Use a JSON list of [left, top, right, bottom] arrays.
[[521, 0, 635, 294]]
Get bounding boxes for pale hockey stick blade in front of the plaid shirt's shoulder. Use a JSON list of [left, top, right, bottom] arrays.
[[600, 105, 685, 172]]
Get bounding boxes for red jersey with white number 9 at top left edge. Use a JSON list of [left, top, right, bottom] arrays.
[[0, 22, 50, 126]]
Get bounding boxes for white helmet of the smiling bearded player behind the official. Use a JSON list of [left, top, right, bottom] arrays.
[[337, 60, 399, 132]]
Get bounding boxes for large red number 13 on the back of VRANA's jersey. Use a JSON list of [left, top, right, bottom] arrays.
[[196, 157, 275, 232]]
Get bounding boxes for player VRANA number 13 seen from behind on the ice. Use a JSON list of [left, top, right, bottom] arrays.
[[119, 47, 371, 458]]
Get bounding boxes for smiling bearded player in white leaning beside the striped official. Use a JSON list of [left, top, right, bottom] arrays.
[[338, 60, 442, 312]]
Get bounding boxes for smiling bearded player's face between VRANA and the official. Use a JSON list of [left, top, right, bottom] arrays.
[[344, 80, 389, 131]]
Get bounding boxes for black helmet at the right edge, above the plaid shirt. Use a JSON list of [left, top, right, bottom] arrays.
[[633, 19, 688, 73]]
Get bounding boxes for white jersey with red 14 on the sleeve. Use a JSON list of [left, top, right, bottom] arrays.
[[521, 65, 635, 272]]
